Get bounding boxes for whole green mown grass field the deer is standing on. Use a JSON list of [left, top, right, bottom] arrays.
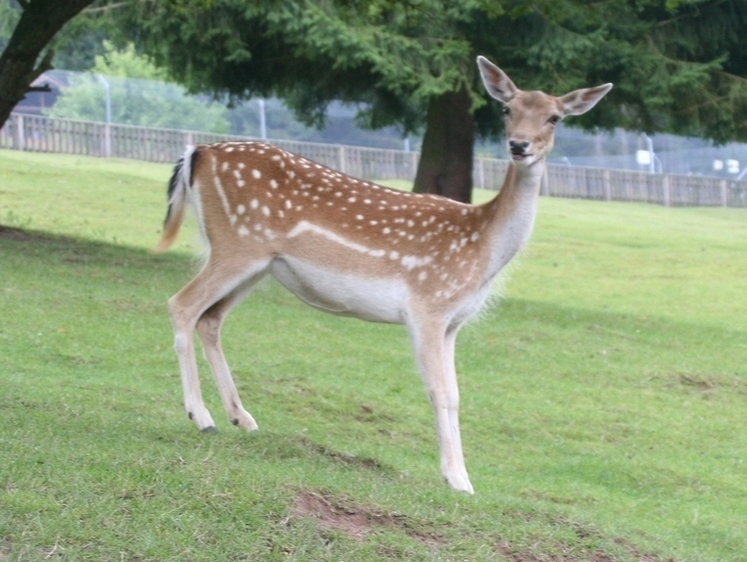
[[0, 151, 747, 562]]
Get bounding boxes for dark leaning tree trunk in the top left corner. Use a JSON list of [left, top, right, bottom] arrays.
[[0, 0, 94, 127]]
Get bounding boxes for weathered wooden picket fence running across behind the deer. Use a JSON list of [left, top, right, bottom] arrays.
[[0, 113, 747, 207]]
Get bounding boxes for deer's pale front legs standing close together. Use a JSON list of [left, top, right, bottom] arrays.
[[409, 319, 474, 494]]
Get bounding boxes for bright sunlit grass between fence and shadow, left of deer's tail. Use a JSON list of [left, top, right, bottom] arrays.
[[0, 150, 199, 250]]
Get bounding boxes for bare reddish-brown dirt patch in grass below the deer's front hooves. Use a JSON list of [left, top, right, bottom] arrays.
[[287, 491, 444, 546]]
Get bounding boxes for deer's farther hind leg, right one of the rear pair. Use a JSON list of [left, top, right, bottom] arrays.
[[197, 273, 263, 431]]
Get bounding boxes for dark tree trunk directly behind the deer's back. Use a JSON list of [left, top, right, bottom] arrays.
[[413, 84, 474, 203]]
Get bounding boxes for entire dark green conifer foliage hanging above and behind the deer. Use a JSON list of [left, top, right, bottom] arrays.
[[118, 0, 747, 141]]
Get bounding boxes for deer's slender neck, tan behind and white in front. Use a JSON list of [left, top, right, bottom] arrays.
[[487, 158, 545, 279]]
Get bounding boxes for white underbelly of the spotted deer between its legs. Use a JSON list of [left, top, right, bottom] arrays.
[[270, 256, 408, 324]]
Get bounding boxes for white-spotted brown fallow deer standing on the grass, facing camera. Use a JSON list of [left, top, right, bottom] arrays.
[[154, 56, 612, 494]]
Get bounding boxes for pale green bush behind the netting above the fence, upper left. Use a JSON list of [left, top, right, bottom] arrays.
[[47, 42, 229, 133]]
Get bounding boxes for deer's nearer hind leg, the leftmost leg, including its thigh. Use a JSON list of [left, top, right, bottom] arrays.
[[169, 257, 267, 431]]
